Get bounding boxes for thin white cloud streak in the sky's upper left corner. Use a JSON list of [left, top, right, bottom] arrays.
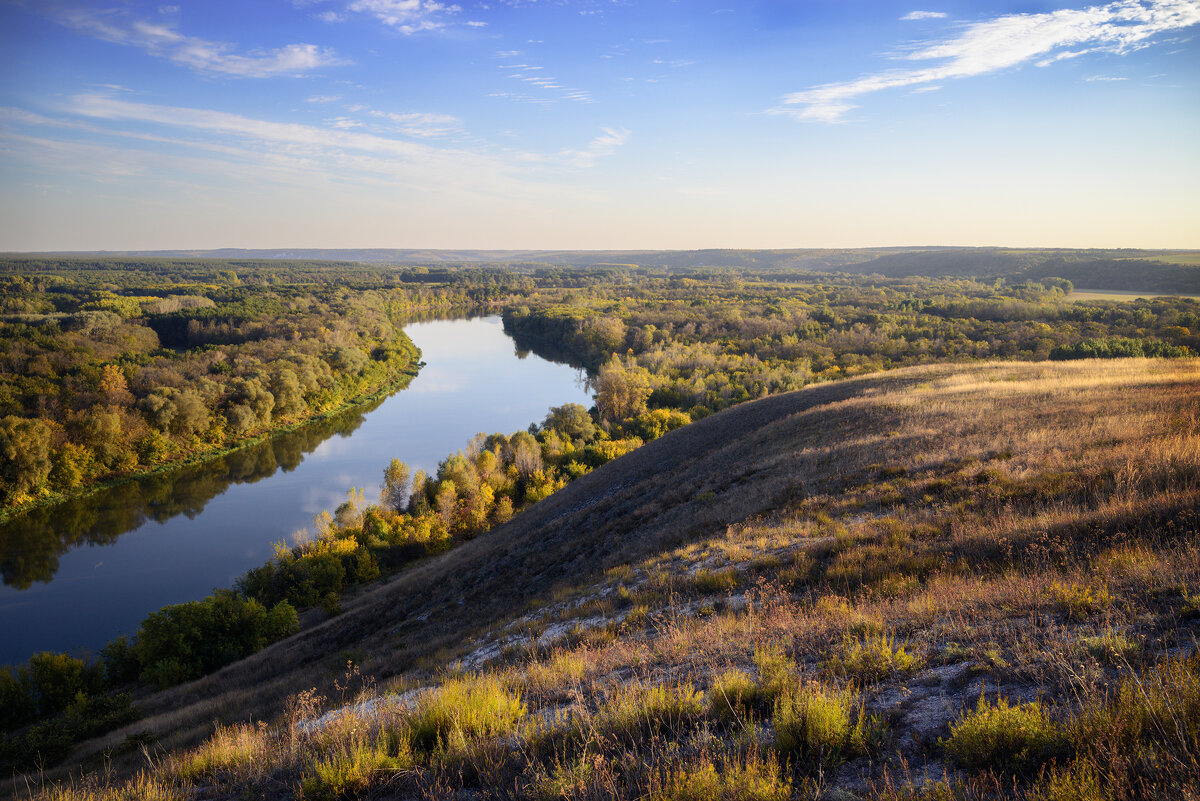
[[52, 8, 347, 78]]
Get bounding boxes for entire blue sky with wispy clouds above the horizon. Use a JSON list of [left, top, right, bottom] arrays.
[[0, 0, 1200, 251]]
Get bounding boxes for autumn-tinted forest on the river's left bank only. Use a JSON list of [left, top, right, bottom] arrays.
[[0, 259, 532, 510]]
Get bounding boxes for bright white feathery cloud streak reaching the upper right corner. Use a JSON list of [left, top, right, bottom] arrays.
[[770, 0, 1200, 122]]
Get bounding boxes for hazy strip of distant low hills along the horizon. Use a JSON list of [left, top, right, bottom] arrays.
[[12, 247, 1200, 294]]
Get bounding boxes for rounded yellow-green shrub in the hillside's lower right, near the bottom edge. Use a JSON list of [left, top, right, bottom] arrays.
[[944, 697, 1067, 773]]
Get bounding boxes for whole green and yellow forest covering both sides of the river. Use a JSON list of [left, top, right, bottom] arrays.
[[0, 259, 1200, 781]]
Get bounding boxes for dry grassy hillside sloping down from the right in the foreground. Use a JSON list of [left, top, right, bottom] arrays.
[[20, 360, 1200, 799]]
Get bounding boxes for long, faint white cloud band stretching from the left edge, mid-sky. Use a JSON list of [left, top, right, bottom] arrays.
[[14, 94, 614, 198]]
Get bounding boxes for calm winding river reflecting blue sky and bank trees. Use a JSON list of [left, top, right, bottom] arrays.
[[0, 318, 592, 663]]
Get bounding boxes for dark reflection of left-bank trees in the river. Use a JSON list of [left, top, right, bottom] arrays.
[[0, 398, 384, 590]]
